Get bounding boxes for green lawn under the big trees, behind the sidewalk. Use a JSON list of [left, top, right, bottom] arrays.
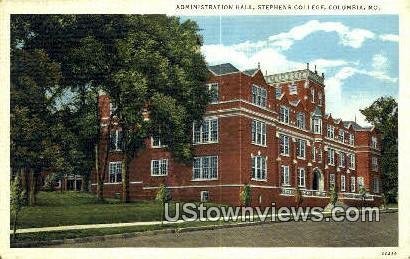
[[13, 192, 224, 229]]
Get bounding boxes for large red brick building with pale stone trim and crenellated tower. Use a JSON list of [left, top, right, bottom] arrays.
[[92, 64, 381, 206]]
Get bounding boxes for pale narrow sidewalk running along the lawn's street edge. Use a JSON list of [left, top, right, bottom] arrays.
[[10, 208, 398, 234]]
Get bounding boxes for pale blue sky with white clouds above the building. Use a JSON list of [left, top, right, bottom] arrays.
[[182, 15, 399, 124]]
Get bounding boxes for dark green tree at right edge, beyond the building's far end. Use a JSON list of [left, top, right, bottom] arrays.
[[360, 97, 398, 202]]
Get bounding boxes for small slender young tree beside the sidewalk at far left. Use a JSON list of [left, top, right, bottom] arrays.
[[10, 174, 26, 240]]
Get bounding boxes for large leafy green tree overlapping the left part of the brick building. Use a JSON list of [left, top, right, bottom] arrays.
[[106, 15, 210, 202]]
